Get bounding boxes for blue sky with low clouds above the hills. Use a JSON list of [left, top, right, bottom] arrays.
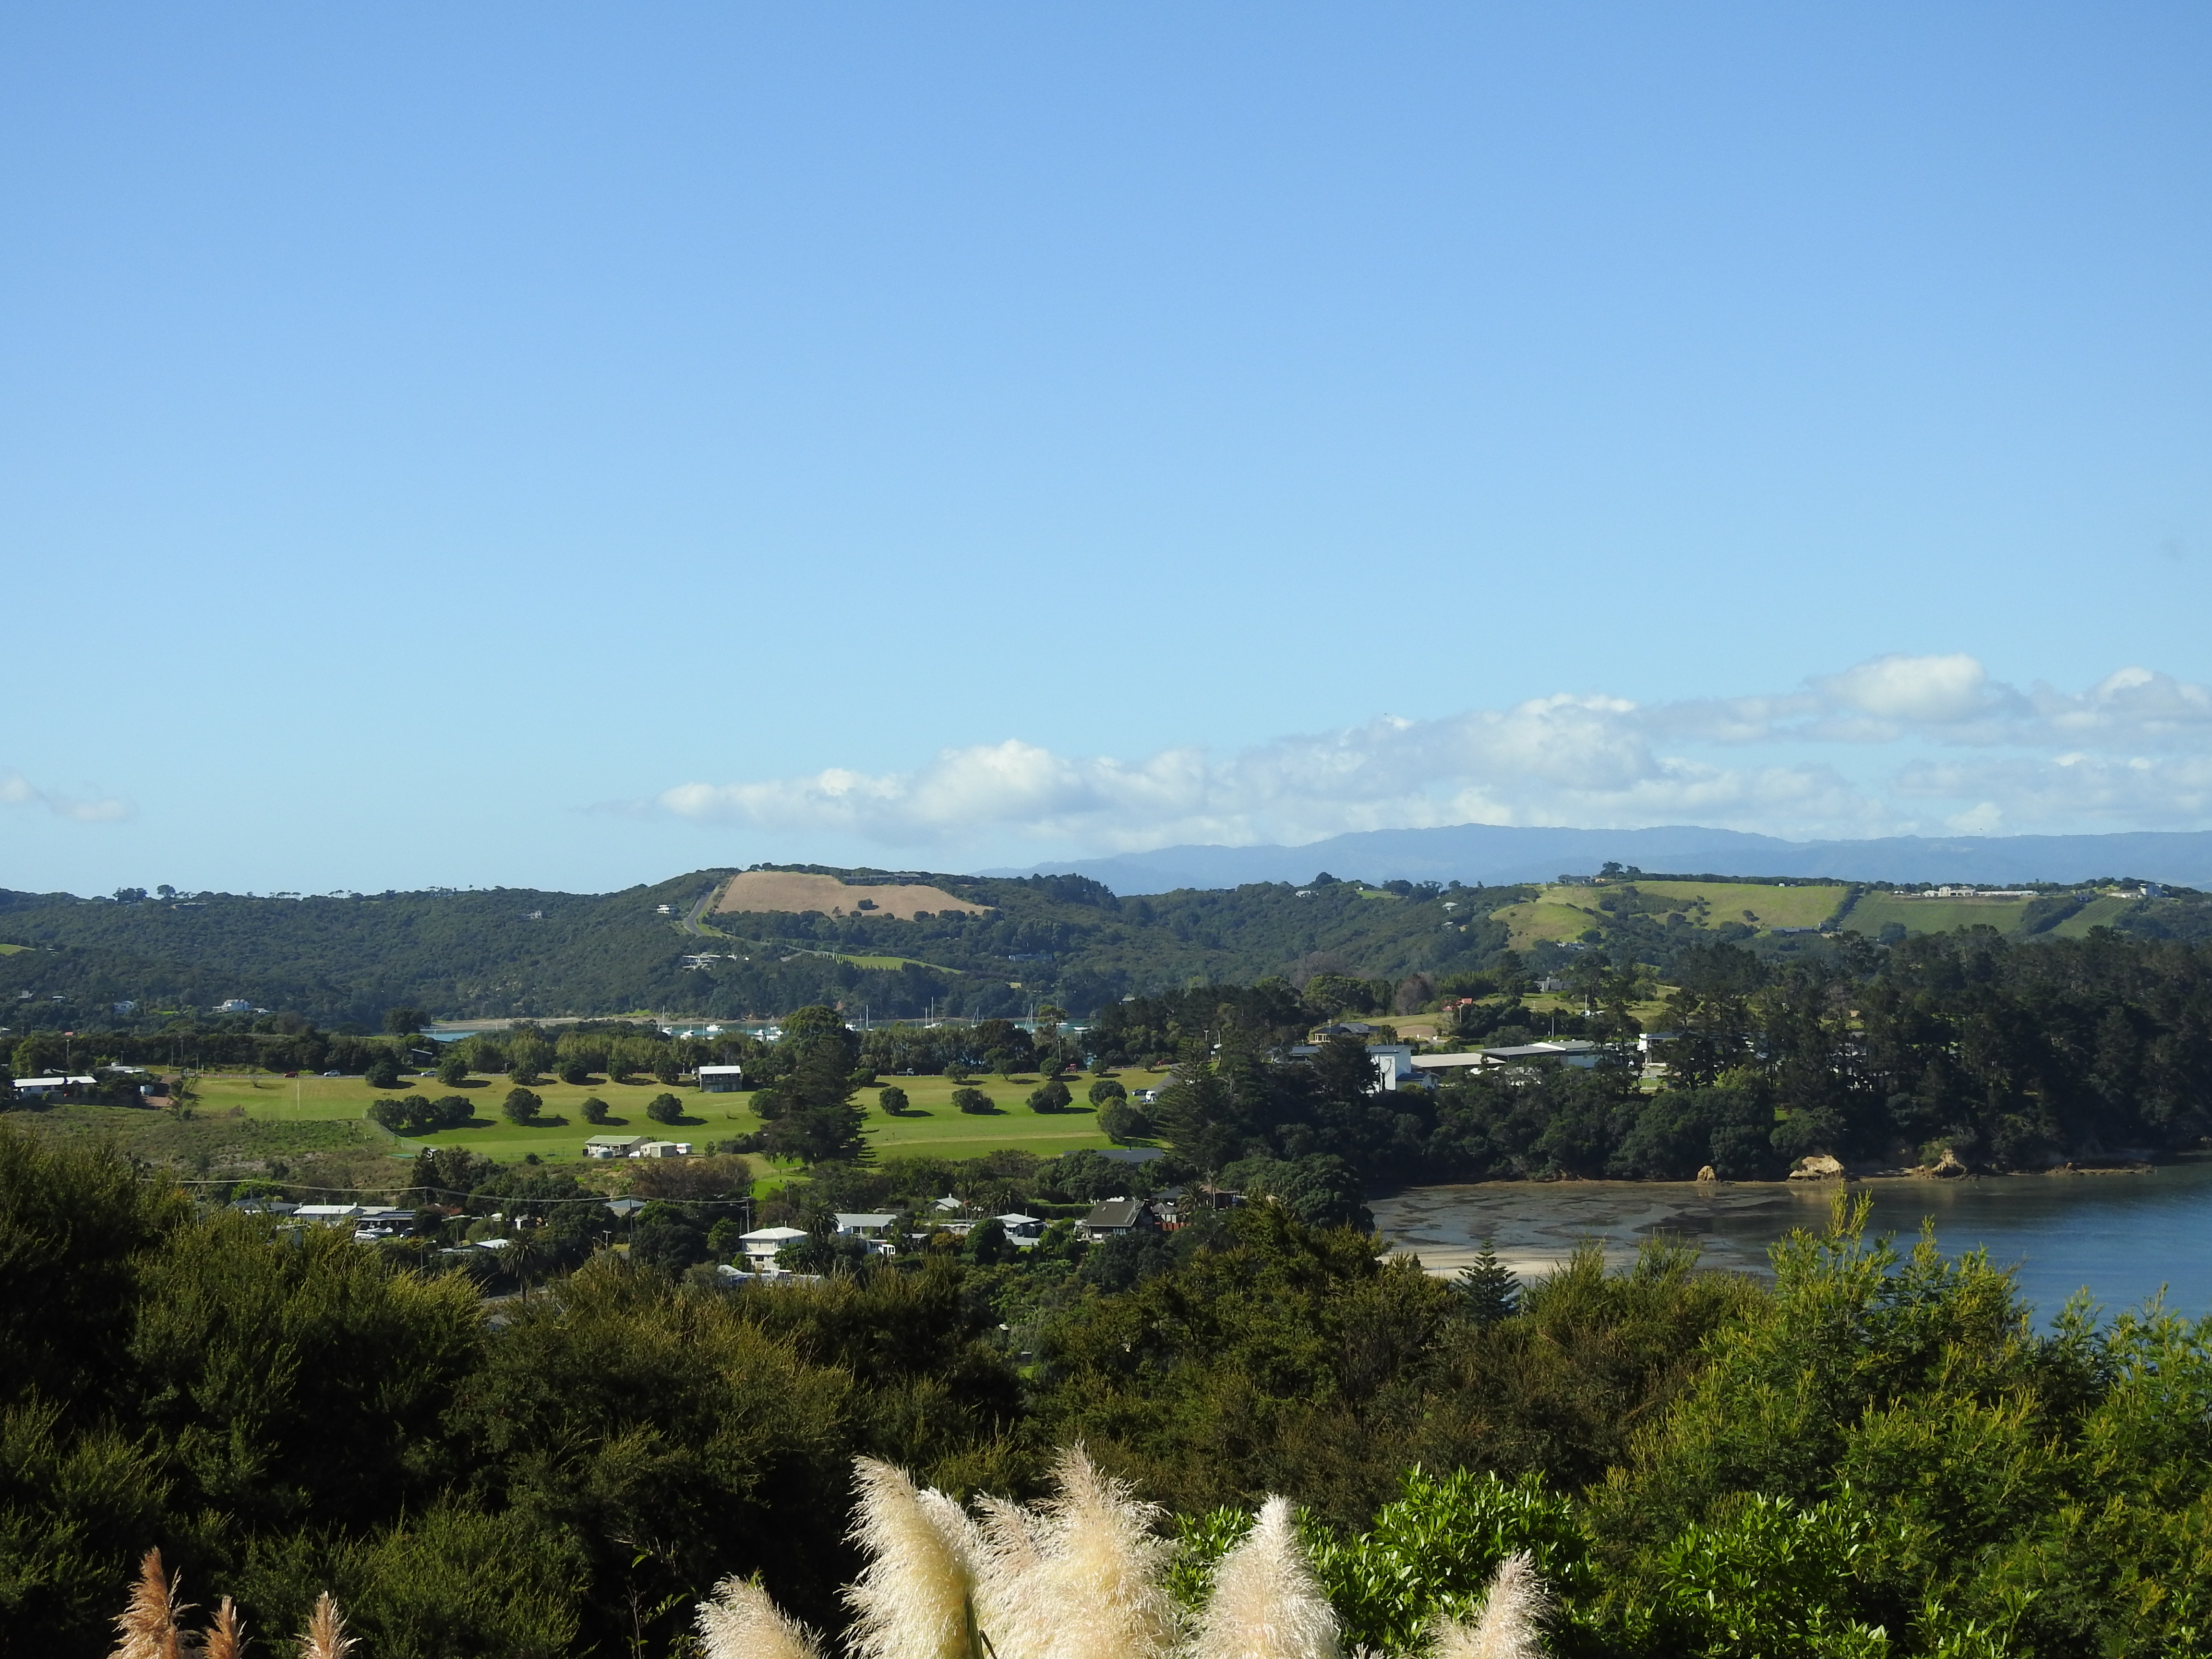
[[0, 2, 2212, 891]]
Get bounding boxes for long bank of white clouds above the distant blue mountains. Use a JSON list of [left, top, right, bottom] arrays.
[[650, 655, 2212, 852]]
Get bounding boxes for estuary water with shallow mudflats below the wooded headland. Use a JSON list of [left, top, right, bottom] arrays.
[[1369, 1161, 2212, 1321]]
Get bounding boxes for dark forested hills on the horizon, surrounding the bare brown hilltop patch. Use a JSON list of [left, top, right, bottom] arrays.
[[0, 869, 2212, 1031]]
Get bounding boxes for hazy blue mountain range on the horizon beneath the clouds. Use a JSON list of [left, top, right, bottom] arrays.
[[978, 823, 2212, 894]]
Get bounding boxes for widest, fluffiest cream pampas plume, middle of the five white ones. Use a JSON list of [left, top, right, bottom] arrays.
[[982, 1447, 1177, 1659]]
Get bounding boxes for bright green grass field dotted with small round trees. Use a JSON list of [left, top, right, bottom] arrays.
[[181, 1069, 1161, 1161]]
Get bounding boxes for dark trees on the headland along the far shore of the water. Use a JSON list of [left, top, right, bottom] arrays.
[[1035, 931, 2212, 1190]]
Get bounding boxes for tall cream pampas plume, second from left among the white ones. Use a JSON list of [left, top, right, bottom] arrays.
[[845, 1458, 982, 1659]]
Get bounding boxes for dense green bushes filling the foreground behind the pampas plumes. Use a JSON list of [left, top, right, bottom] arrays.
[[13, 1128, 2212, 1659]]
